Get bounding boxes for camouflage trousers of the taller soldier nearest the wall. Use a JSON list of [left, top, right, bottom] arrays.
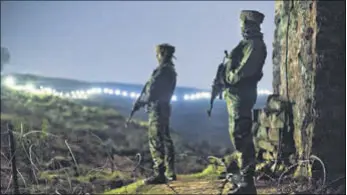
[[225, 87, 257, 177]]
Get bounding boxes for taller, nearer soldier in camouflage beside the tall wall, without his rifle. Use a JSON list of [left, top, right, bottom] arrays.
[[224, 10, 267, 194]]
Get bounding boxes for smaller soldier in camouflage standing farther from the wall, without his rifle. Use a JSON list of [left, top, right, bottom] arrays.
[[145, 44, 177, 184]]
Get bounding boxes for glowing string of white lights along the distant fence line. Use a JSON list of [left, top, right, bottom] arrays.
[[4, 76, 271, 102]]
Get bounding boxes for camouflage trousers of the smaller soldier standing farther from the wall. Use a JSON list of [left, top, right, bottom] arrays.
[[148, 104, 175, 177]]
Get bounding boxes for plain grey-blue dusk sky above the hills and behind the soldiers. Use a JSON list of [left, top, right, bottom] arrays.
[[1, 1, 275, 90]]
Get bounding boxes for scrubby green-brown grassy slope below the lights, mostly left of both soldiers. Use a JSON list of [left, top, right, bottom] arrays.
[[1, 89, 213, 193]]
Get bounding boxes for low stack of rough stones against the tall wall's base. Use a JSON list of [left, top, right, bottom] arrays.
[[252, 95, 295, 172]]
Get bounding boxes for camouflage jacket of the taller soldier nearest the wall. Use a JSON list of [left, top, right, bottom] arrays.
[[225, 38, 267, 86]]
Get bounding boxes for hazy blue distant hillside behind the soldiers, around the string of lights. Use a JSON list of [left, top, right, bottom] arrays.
[[6, 74, 267, 147]]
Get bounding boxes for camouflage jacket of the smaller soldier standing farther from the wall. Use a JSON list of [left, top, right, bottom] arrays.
[[145, 63, 177, 103]]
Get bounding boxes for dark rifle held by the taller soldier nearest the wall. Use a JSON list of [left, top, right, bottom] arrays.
[[207, 50, 228, 117]]
